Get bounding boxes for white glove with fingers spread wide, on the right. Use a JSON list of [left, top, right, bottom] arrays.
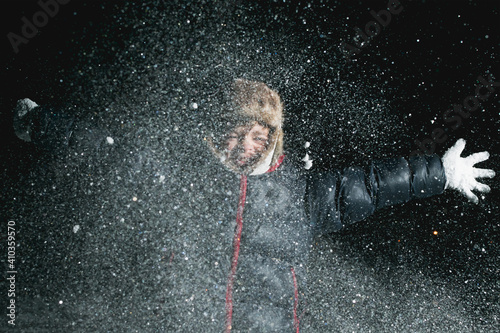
[[441, 139, 495, 204]]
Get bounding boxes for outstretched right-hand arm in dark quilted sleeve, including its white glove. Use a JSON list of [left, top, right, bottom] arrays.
[[306, 140, 495, 233]]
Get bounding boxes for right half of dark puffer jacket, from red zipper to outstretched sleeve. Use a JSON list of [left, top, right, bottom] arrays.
[[214, 155, 446, 332]]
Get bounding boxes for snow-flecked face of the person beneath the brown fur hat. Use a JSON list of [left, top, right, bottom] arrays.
[[225, 122, 269, 171]]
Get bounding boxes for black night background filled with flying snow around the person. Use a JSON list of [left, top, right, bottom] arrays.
[[0, 0, 500, 332]]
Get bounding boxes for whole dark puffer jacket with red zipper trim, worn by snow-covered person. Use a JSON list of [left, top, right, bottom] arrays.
[[21, 105, 446, 332]]
